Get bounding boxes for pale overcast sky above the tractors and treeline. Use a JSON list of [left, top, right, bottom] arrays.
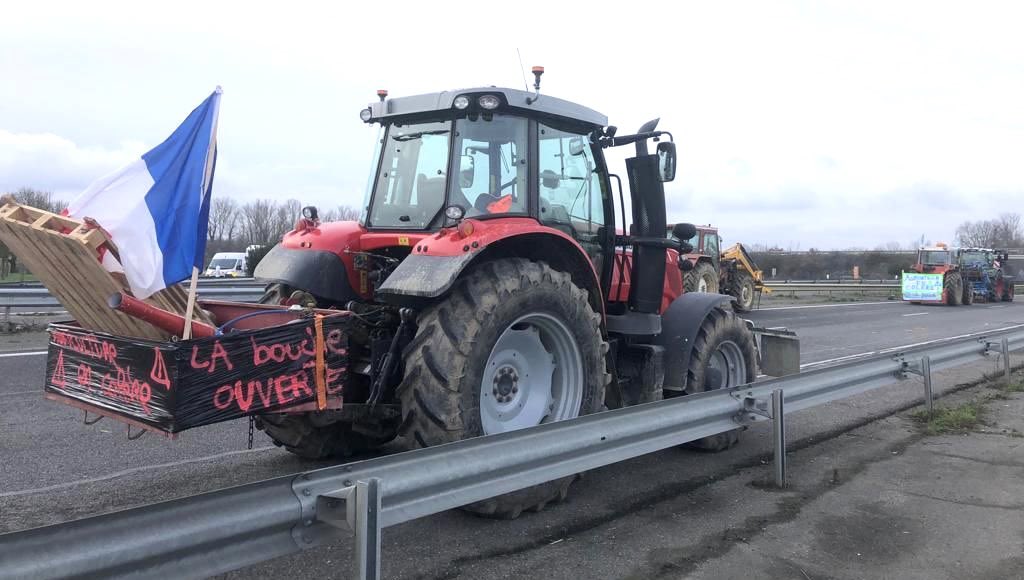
[[0, 1, 1024, 249]]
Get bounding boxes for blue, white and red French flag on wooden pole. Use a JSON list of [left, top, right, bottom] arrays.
[[68, 87, 221, 298]]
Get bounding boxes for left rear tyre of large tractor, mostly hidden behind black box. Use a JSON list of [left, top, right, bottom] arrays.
[[256, 284, 397, 459]]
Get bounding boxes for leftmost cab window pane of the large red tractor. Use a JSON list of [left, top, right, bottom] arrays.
[[367, 121, 452, 230]]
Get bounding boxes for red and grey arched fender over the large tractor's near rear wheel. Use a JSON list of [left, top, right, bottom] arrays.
[[377, 217, 604, 321]]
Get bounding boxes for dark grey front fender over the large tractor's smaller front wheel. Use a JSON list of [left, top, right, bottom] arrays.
[[651, 292, 733, 390]]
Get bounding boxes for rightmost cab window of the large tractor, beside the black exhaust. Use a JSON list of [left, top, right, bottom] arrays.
[[538, 124, 604, 237]]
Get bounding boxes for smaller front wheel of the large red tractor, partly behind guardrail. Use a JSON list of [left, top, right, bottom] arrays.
[[686, 306, 758, 452]]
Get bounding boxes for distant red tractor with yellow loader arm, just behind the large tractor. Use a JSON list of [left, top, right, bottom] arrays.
[[668, 223, 771, 313]]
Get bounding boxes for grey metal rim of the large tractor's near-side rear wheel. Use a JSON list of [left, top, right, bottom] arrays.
[[480, 313, 584, 434]]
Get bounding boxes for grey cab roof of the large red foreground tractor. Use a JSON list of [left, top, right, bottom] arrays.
[[370, 87, 608, 128]]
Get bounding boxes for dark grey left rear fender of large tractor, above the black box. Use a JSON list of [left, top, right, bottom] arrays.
[[253, 243, 358, 304]]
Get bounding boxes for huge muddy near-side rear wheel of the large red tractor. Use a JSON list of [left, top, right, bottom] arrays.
[[398, 258, 609, 519]]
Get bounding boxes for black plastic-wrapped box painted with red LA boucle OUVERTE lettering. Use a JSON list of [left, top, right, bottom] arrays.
[[46, 316, 349, 433]]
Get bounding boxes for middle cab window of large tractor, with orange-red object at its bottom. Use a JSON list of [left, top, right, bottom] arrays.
[[449, 115, 528, 217]]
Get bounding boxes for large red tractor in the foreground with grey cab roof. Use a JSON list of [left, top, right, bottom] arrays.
[[255, 70, 799, 517]]
